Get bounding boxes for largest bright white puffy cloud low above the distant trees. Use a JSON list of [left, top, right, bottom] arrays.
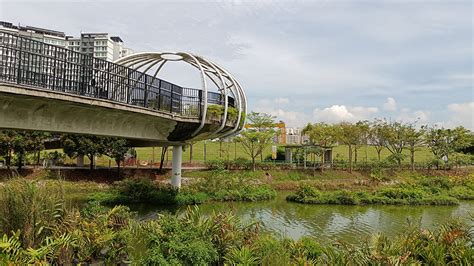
[[313, 105, 378, 123]]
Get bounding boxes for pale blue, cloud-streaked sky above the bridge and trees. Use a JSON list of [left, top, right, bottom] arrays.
[[0, 0, 474, 130]]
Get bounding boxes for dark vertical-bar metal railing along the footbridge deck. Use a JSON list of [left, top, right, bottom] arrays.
[[0, 32, 234, 117]]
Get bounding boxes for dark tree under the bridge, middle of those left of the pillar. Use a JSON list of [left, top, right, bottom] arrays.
[[61, 135, 106, 170]]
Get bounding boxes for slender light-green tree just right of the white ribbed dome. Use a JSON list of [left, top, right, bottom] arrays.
[[239, 112, 275, 171]]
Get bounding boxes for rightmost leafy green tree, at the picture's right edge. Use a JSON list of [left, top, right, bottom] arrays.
[[425, 126, 471, 166]]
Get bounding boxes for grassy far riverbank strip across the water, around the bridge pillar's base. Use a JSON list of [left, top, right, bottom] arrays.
[[0, 168, 474, 205]]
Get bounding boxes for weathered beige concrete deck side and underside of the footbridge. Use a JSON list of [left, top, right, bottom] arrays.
[[0, 82, 231, 147]]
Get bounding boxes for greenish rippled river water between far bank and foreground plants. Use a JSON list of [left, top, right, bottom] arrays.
[[127, 193, 474, 243]]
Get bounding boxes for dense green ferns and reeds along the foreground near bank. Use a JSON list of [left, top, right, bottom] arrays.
[[0, 179, 474, 265]]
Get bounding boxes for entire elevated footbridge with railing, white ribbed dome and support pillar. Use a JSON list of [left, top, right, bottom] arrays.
[[0, 32, 247, 187]]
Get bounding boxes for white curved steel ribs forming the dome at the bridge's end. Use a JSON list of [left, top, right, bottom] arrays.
[[114, 52, 247, 138]]
